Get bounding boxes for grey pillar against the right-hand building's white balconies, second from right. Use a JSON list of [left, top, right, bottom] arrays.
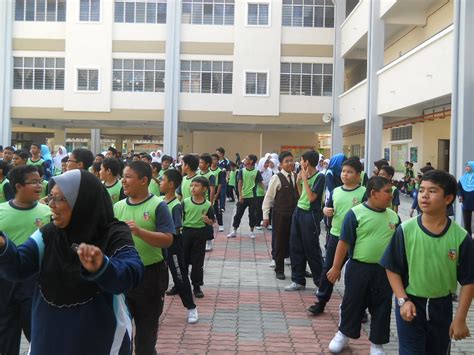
[[365, 0, 384, 175]]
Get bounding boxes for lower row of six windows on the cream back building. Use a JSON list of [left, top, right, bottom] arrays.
[[13, 57, 332, 96]]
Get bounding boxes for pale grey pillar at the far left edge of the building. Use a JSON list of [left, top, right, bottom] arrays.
[[0, 1, 14, 146]]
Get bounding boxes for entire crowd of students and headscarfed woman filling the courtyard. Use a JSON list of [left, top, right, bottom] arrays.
[[0, 145, 474, 354]]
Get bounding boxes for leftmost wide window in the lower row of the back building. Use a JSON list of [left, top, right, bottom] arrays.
[[13, 57, 64, 90]]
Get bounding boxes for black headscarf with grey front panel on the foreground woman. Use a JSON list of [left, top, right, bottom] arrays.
[[39, 170, 134, 307]]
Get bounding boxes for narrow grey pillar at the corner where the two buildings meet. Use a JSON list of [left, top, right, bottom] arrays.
[[331, 0, 346, 155]]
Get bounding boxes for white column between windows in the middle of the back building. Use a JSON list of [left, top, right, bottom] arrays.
[[163, 0, 181, 157]]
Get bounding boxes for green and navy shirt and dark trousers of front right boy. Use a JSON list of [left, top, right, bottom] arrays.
[[380, 215, 474, 355]]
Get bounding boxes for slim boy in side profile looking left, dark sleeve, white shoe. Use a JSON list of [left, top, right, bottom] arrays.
[[160, 169, 199, 324]]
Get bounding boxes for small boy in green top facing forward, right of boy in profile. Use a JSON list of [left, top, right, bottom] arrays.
[[181, 177, 214, 298]]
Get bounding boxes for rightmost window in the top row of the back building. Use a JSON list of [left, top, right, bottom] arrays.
[[282, 0, 334, 28]]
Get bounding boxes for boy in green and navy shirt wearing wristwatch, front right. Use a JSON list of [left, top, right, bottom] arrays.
[[380, 170, 474, 355]]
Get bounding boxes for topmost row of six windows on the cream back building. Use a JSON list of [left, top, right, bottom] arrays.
[[15, 0, 334, 28]]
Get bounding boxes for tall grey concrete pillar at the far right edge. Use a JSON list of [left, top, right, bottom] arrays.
[[449, 0, 474, 223]]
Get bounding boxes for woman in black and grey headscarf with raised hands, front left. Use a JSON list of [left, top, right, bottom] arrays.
[[0, 170, 144, 355]]
